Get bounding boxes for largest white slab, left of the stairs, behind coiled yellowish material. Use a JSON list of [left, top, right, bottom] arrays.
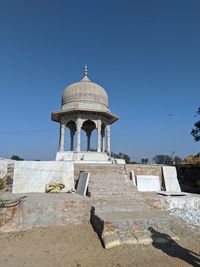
[[12, 161, 74, 193]]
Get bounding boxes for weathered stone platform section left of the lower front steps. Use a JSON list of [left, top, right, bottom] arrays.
[[0, 193, 91, 232]]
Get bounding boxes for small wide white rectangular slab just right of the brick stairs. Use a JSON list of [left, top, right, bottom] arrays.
[[137, 175, 160, 192]]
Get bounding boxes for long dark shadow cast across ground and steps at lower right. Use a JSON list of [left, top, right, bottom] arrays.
[[148, 227, 200, 267]]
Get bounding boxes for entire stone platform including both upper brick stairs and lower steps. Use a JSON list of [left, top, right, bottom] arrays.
[[0, 162, 200, 251]]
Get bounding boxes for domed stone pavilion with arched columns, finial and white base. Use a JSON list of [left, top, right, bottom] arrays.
[[51, 66, 118, 162]]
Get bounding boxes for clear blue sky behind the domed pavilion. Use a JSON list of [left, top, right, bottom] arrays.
[[0, 0, 200, 161]]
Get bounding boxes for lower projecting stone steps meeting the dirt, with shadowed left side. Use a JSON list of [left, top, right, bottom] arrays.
[[90, 198, 179, 249]]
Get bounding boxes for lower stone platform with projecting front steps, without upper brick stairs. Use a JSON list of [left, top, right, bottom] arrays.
[[0, 192, 200, 252]]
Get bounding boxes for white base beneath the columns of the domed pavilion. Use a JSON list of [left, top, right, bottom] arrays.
[[56, 151, 112, 164]]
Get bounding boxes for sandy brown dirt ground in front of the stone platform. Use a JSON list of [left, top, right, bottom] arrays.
[[0, 222, 200, 267]]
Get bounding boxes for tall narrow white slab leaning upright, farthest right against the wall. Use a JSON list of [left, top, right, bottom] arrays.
[[162, 166, 181, 192]]
